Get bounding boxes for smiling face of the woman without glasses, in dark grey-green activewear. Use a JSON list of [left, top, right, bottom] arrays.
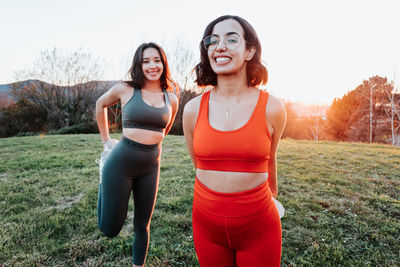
[[142, 47, 164, 81]]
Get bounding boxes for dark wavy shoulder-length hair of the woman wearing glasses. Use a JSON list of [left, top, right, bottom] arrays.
[[194, 15, 268, 86]]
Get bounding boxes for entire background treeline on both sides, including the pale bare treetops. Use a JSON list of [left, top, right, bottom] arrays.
[[0, 48, 400, 145]]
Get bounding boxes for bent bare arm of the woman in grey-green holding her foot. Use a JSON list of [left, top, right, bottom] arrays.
[[96, 84, 125, 143]]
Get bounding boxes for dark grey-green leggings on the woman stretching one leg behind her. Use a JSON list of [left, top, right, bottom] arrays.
[[97, 137, 161, 265]]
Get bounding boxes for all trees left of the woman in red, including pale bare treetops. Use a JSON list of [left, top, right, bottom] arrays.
[[0, 48, 197, 137]]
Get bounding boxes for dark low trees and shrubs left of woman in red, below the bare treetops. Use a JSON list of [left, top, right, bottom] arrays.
[[0, 80, 197, 137]]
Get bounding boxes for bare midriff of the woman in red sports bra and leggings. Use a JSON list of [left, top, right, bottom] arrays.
[[196, 169, 268, 193]]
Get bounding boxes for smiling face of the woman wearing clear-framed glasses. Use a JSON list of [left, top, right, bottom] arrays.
[[208, 19, 253, 75]]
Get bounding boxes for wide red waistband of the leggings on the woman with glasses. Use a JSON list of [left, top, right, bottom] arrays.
[[193, 177, 273, 217]]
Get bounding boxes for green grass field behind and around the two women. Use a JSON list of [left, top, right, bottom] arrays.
[[0, 135, 400, 266]]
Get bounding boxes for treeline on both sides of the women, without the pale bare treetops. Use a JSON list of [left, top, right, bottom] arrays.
[[0, 76, 400, 145]]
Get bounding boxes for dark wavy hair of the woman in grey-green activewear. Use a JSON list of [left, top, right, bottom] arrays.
[[125, 42, 176, 92]]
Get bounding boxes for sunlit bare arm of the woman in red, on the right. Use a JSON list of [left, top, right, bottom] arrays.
[[266, 96, 286, 198]]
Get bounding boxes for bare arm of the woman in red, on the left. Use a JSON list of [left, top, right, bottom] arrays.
[[182, 95, 201, 169]]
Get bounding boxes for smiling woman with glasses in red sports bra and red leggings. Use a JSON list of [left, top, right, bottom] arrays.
[[183, 16, 286, 267]]
